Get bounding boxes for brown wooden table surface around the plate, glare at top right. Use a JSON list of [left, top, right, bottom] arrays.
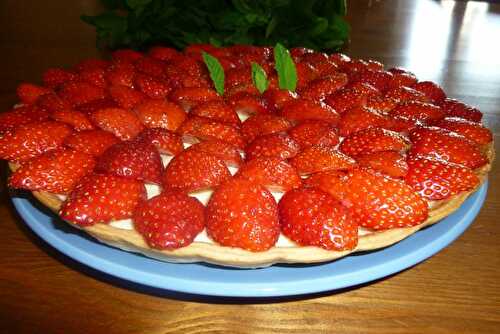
[[0, 0, 500, 334]]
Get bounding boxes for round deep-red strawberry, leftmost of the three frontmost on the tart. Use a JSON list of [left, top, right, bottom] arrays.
[[133, 191, 205, 250]]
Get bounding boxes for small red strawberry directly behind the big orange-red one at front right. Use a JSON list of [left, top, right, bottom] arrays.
[[356, 151, 408, 178]]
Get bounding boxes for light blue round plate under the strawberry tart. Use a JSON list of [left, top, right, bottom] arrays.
[[13, 183, 487, 297]]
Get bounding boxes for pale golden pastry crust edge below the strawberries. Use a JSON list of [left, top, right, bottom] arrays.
[[9, 143, 494, 268]]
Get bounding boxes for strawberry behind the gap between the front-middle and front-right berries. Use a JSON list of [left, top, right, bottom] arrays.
[[235, 158, 302, 192]]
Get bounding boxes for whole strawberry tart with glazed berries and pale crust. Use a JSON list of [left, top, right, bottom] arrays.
[[0, 45, 494, 268]]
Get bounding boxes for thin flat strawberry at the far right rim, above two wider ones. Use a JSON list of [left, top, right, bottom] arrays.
[[433, 117, 493, 145]]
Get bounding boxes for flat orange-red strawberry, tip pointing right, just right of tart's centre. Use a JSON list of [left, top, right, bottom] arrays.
[[290, 145, 356, 175]]
